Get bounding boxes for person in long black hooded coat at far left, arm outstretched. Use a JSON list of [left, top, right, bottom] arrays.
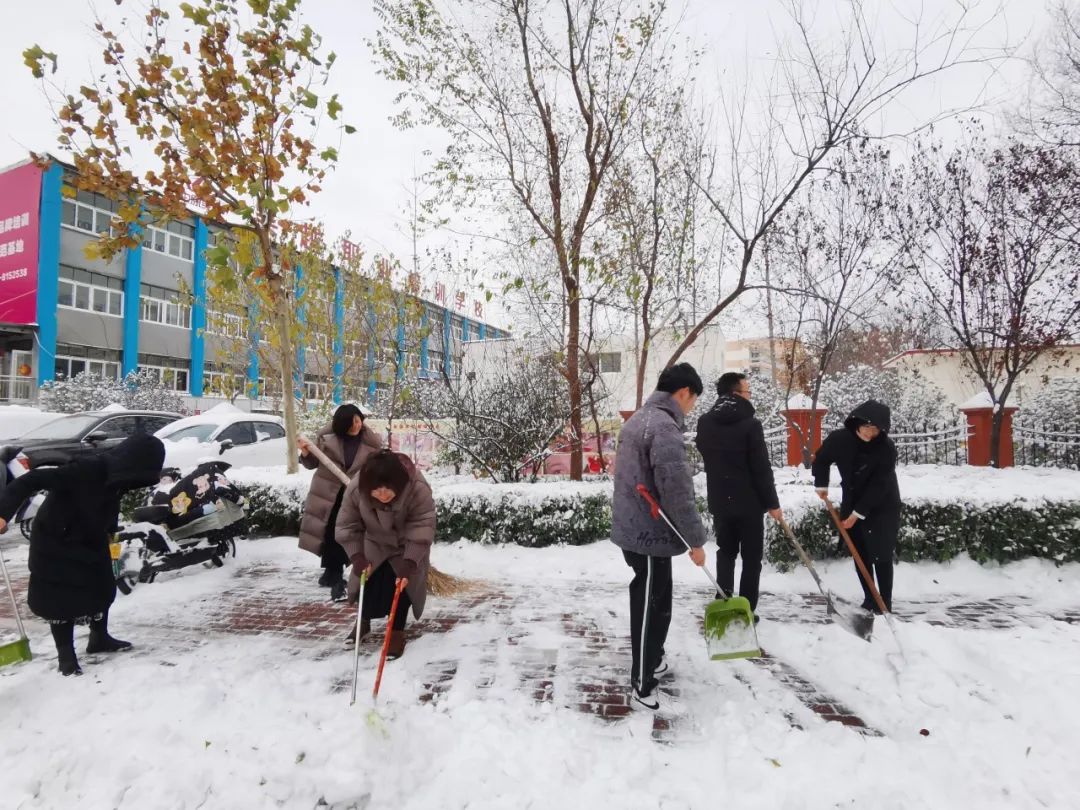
[[0, 434, 165, 675]]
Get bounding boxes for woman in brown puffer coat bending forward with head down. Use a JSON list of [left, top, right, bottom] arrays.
[[336, 450, 435, 658]]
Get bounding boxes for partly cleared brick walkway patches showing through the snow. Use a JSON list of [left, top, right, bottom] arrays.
[[0, 554, 1080, 743]]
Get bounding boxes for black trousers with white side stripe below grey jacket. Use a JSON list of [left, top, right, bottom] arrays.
[[622, 551, 672, 694]]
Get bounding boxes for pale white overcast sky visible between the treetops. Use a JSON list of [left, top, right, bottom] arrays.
[[0, 0, 1048, 330]]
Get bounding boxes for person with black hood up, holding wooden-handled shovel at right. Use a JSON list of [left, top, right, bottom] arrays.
[[812, 400, 901, 612]]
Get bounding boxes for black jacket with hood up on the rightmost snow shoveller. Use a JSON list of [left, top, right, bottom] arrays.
[[811, 400, 900, 517]]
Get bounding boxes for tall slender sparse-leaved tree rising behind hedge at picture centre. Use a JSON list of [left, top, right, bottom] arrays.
[[374, 0, 670, 480]]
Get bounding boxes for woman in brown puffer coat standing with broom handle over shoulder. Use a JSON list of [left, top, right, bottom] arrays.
[[299, 404, 382, 599]]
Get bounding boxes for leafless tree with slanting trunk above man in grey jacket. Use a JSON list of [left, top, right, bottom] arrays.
[[667, 0, 1007, 365]]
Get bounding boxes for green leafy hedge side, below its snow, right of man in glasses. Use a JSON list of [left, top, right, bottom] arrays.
[[767, 501, 1080, 568]]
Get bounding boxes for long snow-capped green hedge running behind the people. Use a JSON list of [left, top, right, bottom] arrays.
[[212, 465, 1080, 566]]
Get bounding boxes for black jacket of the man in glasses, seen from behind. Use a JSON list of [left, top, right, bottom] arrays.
[[694, 394, 780, 515]]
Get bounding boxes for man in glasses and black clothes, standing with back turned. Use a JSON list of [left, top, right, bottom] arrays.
[[696, 372, 783, 620]]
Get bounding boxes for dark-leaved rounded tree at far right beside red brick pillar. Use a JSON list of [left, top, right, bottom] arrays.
[[895, 130, 1080, 465]]
